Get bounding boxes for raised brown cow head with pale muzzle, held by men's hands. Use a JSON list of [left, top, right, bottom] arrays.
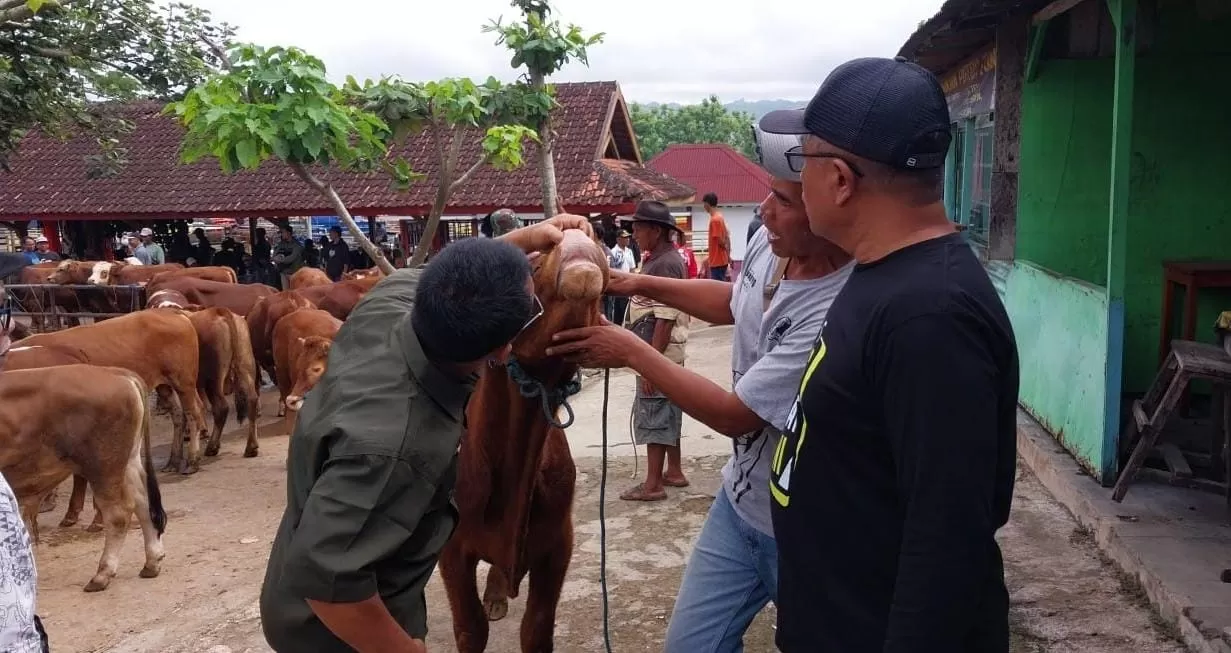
[[513, 229, 608, 361]]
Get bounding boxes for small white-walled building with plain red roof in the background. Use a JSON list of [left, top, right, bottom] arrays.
[[646, 143, 769, 263]]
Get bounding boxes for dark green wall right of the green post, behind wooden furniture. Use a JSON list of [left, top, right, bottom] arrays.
[[1124, 5, 1231, 392]]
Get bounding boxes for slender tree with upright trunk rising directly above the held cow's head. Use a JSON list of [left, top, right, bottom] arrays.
[[484, 0, 603, 216]]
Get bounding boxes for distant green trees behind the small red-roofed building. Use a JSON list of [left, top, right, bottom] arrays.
[[629, 95, 755, 159]]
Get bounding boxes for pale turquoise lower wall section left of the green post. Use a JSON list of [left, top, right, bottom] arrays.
[[1004, 258, 1115, 473]]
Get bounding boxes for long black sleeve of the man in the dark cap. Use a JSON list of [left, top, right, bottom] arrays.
[[874, 309, 1000, 653]]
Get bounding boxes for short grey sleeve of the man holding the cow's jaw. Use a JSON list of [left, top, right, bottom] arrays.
[[735, 320, 816, 431]]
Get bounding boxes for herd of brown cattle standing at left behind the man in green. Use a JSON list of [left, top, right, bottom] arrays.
[[0, 261, 380, 591]]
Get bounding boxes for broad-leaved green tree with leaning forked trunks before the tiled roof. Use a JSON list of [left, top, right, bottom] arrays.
[[167, 44, 542, 274]]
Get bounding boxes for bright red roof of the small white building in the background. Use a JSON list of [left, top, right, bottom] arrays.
[[646, 143, 769, 205]]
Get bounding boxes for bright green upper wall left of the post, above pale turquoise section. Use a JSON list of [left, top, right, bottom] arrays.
[[1017, 60, 1113, 286]]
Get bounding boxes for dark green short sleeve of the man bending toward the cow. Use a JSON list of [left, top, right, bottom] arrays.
[[284, 455, 436, 602]]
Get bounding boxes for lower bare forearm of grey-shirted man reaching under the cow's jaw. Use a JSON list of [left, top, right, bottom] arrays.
[[629, 337, 766, 437]]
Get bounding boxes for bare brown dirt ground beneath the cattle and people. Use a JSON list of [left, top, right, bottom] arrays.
[[26, 331, 1184, 653]]
